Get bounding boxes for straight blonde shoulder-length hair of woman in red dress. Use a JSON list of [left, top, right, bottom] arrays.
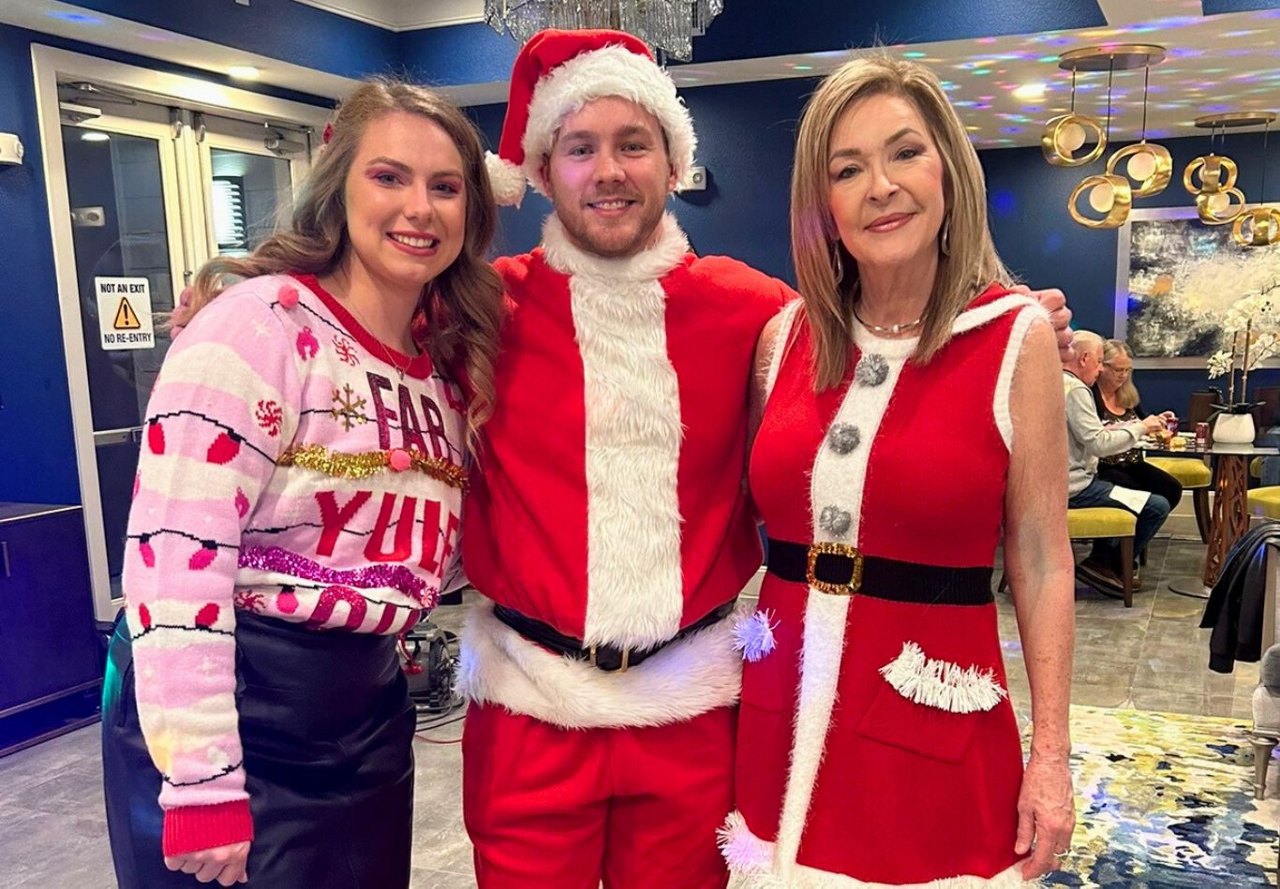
[[791, 52, 1012, 391]]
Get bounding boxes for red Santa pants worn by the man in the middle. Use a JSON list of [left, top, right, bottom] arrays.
[[462, 705, 737, 889]]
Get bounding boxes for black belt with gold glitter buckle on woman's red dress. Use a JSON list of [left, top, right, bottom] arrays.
[[768, 537, 995, 605]]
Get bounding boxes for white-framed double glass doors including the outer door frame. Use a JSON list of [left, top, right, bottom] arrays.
[[31, 45, 330, 620]]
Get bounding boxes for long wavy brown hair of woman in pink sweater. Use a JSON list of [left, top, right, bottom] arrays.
[[183, 78, 502, 443]]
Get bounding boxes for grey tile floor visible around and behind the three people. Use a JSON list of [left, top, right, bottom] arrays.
[[0, 540, 1275, 889]]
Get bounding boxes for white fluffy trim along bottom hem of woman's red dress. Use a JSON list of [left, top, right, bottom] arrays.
[[717, 812, 1042, 889]]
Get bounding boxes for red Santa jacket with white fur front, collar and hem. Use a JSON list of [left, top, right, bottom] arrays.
[[462, 216, 794, 727]]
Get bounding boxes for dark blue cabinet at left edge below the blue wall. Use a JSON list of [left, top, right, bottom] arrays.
[[0, 503, 104, 755]]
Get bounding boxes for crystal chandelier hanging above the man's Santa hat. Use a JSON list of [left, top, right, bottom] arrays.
[[484, 0, 724, 61]]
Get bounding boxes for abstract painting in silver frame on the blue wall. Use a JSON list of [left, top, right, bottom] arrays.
[[1115, 207, 1280, 367]]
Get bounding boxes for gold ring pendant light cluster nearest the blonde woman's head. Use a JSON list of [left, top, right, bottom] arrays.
[[1041, 43, 1174, 229]]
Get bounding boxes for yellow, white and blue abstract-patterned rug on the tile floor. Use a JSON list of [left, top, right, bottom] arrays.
[[1044, 706, 1280, 889]]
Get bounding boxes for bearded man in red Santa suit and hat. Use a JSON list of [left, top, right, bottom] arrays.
[[461, 31, 1069, 889]]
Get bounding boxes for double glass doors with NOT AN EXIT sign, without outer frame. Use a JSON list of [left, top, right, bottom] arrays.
[[61, 102, 310, 599]]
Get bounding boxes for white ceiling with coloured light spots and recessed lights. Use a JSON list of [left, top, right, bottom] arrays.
[[0, 0, 1280, 148]]
